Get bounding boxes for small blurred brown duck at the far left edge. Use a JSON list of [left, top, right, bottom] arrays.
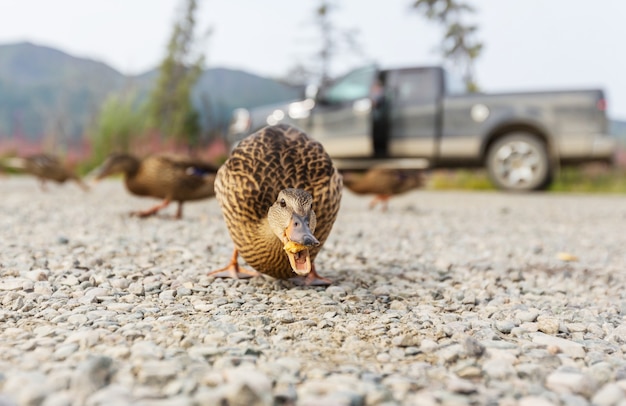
[[3, 154, 89, 191]]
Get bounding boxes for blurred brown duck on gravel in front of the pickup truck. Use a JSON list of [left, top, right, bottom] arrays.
[[342, 167, 424, 211]]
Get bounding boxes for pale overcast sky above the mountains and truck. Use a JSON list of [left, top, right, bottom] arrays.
[[0, 0, 626, 120]]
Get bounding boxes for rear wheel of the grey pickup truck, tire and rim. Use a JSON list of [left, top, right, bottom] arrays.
[[486, 132, 552, 192]]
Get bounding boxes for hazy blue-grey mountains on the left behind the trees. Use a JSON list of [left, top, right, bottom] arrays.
[[0, 42, 300, 142]]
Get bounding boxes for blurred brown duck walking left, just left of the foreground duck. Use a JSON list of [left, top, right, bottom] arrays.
[[93, 154, 217, 219]]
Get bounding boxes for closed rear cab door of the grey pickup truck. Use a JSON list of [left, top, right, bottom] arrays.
[[387, 67, 443, 158]]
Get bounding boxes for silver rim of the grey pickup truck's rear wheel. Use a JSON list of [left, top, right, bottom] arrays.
[[495, 141, 541, 188]]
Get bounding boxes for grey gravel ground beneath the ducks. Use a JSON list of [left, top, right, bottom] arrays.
[[0, 176, 626, 406]]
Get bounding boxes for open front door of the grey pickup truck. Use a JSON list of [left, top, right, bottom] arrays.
[[308, 65, 378, 158]]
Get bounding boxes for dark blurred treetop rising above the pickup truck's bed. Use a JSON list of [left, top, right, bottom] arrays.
[[413, 0, 483, 92]]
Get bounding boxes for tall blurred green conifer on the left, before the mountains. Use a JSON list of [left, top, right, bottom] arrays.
[[148, 0, 204, 145]]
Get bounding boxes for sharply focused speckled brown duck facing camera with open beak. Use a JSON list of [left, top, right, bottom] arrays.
[[209, 124, 342, 285]]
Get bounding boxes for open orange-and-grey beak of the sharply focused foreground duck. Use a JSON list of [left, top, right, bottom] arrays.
[[283, 214, 320, 275]]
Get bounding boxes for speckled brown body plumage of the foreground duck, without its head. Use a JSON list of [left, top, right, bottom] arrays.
[[215, 124, 342, 279]]
